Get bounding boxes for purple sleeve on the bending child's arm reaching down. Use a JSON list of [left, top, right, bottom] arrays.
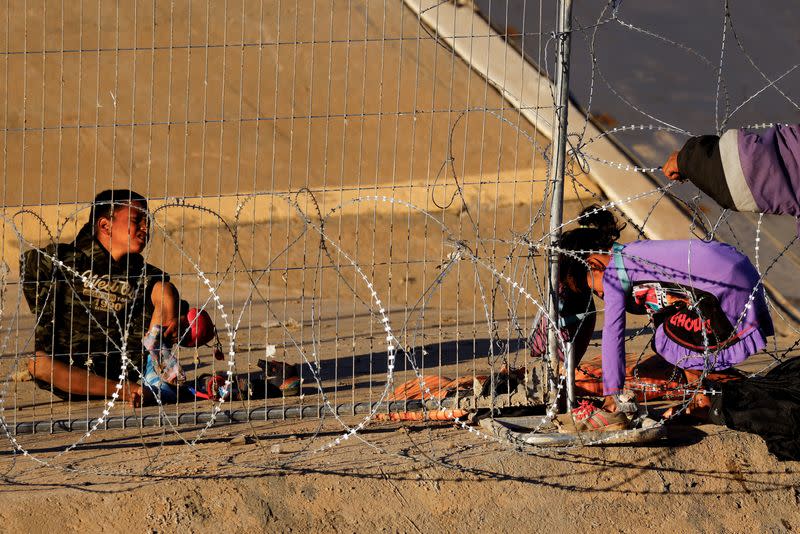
[[602, 266, 625, 395]]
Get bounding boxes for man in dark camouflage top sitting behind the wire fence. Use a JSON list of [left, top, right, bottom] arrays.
[[20, 189, 180, 405]]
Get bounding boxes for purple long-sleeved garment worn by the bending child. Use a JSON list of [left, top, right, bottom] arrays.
[[602, 240, 774, 395]]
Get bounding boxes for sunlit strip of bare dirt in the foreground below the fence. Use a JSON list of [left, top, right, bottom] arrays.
[[0, 421, 800, 532]]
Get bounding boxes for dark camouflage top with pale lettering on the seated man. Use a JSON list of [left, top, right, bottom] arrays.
[[20, 228, 169, 366]]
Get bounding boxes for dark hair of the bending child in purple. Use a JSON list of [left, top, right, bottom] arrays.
[[558, 204, 625, 292]]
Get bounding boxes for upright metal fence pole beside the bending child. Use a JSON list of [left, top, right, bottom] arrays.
[[547, 0, 575, 409]]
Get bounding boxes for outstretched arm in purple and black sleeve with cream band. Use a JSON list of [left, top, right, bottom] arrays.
[[662, 124, 800, 229]]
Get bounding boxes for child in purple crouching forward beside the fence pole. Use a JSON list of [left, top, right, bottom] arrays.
[[559, 206, 774, 430]]
